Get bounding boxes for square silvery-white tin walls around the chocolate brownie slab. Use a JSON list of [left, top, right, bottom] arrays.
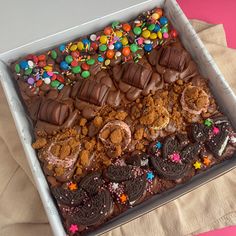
[[0, 0, 236, 236]]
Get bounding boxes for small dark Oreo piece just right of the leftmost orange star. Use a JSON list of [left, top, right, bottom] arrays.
[[80, 172, 103, 195]]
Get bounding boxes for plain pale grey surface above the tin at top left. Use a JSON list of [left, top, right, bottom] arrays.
[[0, 0, 148, 53]]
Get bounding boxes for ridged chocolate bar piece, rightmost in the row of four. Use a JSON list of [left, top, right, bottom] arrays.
[[159, 47, 187, 72]]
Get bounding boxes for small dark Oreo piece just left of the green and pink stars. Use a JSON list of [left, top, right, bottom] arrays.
[[189, 123, 210, 143]]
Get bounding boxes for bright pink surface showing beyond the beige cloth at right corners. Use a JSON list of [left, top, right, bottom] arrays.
[[177, 0, 236, 236]]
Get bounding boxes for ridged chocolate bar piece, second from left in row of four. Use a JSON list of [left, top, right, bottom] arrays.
[[77, 79, 110, 106]]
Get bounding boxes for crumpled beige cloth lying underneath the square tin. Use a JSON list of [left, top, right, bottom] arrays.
[[0, 20, 236, 236]]
